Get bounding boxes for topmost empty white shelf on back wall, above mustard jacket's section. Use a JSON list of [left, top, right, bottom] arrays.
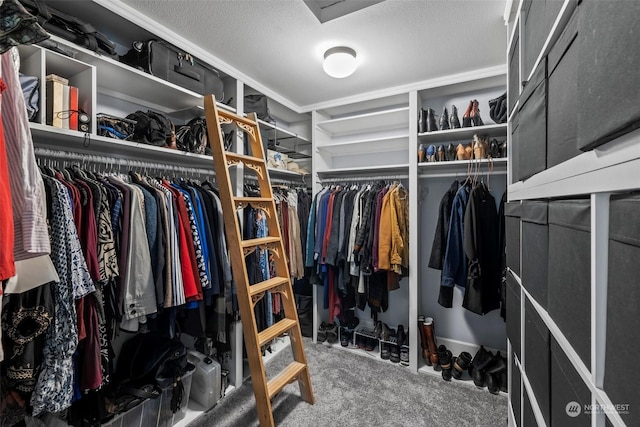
[[317, 107, 409, 136]]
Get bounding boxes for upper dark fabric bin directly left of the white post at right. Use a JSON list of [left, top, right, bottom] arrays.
[[548, 200, 591, 366]]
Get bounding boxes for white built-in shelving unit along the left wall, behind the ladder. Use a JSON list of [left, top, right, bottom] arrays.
[[19, 0, 311, 425]]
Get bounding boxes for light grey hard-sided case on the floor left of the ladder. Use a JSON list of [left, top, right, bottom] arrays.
[[189, 350, 221, 410]]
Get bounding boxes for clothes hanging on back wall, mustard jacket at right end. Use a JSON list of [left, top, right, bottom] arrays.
[[305, 176, 409, 324]]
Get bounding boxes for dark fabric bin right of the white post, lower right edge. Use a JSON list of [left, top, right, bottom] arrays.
[[604, 194, 640, 425]]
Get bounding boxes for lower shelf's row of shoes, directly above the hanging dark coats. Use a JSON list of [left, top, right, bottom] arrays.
[[418, 135, 507, 163]]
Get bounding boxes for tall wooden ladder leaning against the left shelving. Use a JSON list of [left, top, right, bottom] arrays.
[[204, 95, 314, 426]]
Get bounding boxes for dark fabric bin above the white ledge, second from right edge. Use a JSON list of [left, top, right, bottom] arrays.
[[547, 9, 582, 167]]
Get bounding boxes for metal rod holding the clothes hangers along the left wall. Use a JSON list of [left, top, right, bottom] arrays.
[[34, 147, 215, 176]]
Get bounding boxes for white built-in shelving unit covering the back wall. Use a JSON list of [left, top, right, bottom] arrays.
[[313, 67, 507, 384]]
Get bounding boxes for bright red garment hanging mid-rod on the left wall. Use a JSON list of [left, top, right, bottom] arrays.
[[162, 181, 202, 301]]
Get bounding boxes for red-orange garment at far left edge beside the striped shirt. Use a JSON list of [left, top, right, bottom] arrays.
[[0, 79, 16, 280]]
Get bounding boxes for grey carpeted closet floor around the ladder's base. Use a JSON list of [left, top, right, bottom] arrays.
[[191, 338, 507, 427]]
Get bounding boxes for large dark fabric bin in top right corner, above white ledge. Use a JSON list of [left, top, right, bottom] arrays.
[[578, 0, 640, 150]]
